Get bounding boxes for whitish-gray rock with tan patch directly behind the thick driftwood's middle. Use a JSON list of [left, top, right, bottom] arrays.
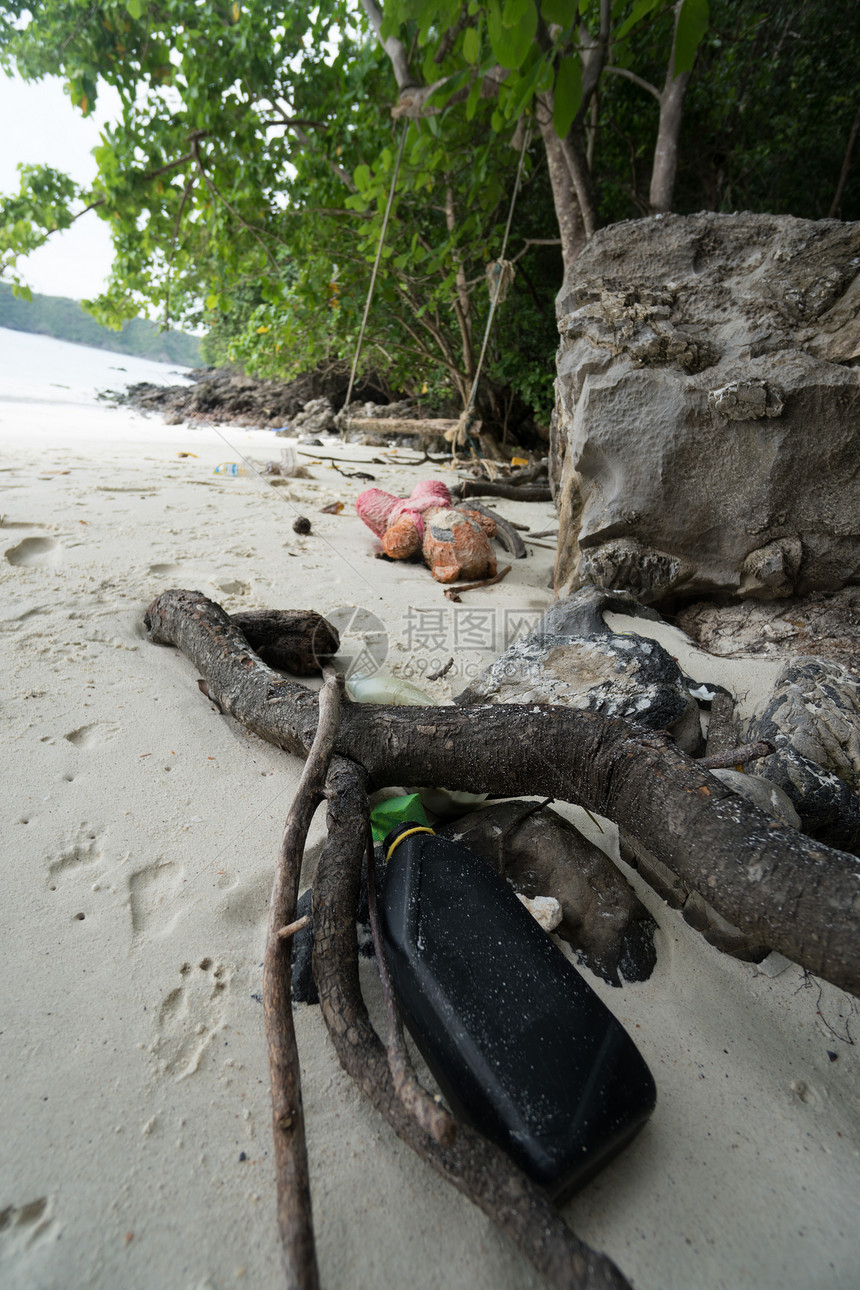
[[456, 586, 701, 752]]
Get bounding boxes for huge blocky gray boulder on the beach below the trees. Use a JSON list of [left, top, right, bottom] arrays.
[[551, 213, 860, 604]]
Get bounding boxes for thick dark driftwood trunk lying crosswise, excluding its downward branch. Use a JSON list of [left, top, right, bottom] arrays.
[[147, 591, 860, 995]]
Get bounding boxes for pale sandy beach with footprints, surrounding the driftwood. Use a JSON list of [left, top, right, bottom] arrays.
[[0, 333, 860, 1290]]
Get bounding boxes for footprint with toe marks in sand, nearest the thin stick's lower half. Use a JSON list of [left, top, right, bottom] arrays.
[[150, 958, 232, 1084]]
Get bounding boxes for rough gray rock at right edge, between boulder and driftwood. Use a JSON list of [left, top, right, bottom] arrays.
[[749, 658, 860, 854]]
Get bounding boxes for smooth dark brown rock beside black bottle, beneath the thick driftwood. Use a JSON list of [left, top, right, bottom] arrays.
[[436, 801, 656, 986]]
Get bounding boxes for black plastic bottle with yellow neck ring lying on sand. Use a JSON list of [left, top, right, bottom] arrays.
[[379, 823, 656, 1200]]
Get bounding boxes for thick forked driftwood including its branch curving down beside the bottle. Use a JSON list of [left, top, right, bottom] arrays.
[[146, 591, 860, 1290]]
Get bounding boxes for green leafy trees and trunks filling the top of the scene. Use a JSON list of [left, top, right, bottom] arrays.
[[0, 0, 860, 419]]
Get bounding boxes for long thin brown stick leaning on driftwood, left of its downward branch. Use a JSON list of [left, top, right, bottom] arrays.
[[263, 666, 340, 1290]]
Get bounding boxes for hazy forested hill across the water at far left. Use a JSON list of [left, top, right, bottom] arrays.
[[0, 283, 200, 368]]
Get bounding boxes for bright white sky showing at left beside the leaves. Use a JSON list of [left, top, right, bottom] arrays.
[[0, 72, 119, 301]]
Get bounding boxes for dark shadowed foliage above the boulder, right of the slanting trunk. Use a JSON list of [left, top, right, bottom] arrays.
[[677, 0, 860, 219]]
